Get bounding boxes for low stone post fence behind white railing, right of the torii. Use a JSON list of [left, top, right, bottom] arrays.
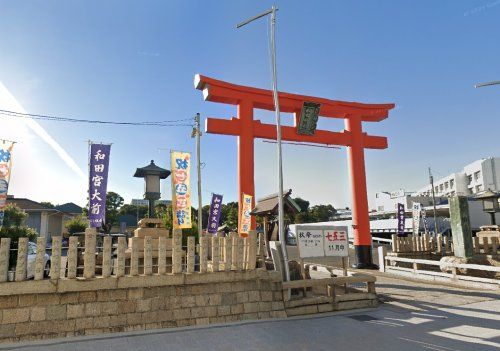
[[392, 234, 499, 256]]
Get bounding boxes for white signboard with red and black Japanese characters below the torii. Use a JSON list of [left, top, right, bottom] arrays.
[[295, 224, 349, 258]]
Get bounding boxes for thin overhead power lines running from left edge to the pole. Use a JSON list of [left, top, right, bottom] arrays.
[[0, 109, 193, 127]]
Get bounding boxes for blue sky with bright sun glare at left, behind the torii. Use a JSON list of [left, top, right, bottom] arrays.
[[0, 0, 500, 207]]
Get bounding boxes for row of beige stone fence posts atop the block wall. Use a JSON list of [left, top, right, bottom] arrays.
[[0, 230, 264, 282]]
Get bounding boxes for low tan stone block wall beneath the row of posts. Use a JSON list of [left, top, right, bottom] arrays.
[[0, 269, 286, 342]]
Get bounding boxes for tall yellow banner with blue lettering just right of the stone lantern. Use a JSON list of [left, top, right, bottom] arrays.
[[170, 151, 191, 229]]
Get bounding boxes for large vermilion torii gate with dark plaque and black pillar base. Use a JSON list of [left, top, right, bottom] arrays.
[[194, 74, 394, 268]]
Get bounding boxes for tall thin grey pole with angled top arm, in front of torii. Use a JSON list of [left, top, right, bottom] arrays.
[[236, 5, 290, 280]]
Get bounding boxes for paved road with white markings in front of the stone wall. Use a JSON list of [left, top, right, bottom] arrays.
[[0, 275, 500, 351]]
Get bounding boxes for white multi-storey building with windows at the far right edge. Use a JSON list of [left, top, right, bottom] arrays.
[[415, 157, 500, 196]]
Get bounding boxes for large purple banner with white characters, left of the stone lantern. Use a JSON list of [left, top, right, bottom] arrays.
[[89, 144, 111, 228]]
